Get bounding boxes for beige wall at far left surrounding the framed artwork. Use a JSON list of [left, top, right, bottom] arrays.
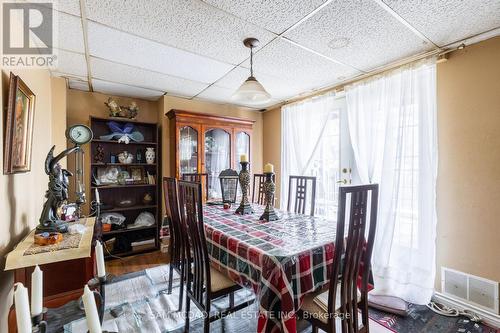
[[0, 69, 64, 332]]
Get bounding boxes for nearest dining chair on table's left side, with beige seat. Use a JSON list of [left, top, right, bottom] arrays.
[[178, 181, 253, 333]]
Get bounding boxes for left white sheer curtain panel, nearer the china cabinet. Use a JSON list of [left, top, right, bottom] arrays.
[[280, 93, 338, 212]]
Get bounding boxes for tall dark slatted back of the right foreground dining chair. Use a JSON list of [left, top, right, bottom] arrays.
[[328, 184, 378, 333]]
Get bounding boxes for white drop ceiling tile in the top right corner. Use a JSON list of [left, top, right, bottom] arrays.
[[383, 0, 500, 46]]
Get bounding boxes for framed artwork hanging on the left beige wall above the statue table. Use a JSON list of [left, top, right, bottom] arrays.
[[3, 73, 35, 174]]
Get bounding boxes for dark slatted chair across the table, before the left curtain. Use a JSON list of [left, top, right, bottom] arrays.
[[287, 176, 316, 216]]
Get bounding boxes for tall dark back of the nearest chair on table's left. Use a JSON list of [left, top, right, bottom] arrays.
[[178, 180, 210, 307]]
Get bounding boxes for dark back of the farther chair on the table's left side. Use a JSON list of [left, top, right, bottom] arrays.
[[163, 177, 185, 266]]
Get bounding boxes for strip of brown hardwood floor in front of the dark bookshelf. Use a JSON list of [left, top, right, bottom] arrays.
[[106, 251, 170, 275]]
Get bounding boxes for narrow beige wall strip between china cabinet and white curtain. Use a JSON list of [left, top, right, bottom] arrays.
[[263, 108, 281, 207]]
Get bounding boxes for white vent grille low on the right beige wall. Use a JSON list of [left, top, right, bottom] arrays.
[[441, 267, 500, 315]]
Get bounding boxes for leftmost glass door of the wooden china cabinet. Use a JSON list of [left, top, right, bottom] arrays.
[[179, 126, 198, 176]]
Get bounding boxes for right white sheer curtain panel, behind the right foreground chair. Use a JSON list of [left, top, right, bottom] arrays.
[[346, 60, 437, 304]]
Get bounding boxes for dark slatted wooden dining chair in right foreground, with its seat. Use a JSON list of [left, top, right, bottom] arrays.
[[298, 184, 378, 333]]
